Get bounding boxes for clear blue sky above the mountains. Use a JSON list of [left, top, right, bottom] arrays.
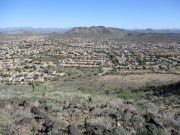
[[0, 0, 180, 29]]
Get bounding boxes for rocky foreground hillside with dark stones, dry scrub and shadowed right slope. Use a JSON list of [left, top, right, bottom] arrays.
[[0, 82, 180, 135]]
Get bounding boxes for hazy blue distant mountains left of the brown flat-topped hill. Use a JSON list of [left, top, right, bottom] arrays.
[[0, 27, 70, 34]]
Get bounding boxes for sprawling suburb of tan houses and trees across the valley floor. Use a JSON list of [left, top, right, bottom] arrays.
[[0, 38, 180, 84]]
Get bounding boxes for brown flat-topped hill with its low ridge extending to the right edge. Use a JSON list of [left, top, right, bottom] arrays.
[[48, 26, 180, 42]]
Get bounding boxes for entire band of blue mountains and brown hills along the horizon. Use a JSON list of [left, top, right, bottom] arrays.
[[0, 26, 180, 42]]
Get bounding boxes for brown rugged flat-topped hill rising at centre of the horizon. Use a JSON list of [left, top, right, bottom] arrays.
[[64, 26, 129, 38]]
